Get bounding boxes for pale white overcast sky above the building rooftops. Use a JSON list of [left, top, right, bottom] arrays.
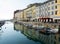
[[0, 0, 47, 20]]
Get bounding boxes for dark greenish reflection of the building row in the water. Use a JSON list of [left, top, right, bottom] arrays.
[[15, 24, 60, 44]]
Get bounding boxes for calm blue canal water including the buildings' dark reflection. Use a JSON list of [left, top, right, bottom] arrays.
[[0, 22, 60, 44]]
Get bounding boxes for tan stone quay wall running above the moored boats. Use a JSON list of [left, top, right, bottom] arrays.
[[15, 21, 60, 28]]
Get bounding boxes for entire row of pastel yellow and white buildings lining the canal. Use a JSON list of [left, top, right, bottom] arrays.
[[13, 0, 60, 22]]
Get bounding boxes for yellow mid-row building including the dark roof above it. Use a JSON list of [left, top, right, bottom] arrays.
[[24, 3, 40, 21]]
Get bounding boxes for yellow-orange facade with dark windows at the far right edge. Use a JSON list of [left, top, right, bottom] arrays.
[[51, 0, 60, 21]]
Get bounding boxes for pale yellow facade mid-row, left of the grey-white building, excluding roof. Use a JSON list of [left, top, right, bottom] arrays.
[[24, 5, 36, 20]]
